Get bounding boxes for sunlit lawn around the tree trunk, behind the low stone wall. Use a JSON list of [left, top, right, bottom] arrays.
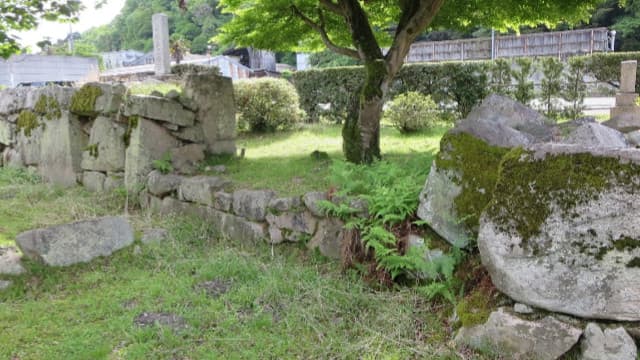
[[205, 125, 447, 195]]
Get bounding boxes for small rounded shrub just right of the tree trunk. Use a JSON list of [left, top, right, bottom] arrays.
[[384, 91, 440, 133]]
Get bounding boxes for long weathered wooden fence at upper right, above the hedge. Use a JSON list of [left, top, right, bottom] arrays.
[[406, 28, 612, 63]]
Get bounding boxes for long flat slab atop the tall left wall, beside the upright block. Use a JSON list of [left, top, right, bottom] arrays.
[[124, 95, 196, 126]]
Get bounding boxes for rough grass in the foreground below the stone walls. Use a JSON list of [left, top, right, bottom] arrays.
[[0, 169, 478, 359]]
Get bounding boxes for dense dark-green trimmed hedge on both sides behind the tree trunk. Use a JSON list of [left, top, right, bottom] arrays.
[[293, 61, 490, 121]]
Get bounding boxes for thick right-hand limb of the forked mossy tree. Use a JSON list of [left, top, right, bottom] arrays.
[[386, 0, 444, 74]]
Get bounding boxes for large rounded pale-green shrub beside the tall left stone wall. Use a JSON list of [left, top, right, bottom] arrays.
[[234, 78, 305, 132]]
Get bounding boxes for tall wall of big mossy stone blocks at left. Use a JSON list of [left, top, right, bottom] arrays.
[[0, 74, 236, 191]]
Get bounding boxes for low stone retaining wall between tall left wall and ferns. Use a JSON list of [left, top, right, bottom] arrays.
[[140, 171, 344, 258]]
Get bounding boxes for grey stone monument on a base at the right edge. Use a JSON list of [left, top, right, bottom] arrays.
[[603, 60, 640, 133]]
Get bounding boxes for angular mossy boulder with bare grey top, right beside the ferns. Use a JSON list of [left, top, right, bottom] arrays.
[[418, 95, 552, 247]]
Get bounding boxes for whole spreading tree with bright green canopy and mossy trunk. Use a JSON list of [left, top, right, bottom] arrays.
[[217, 0, 602, 162]]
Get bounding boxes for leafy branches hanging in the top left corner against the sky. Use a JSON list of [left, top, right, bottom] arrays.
[[0, 0, 82, 59]]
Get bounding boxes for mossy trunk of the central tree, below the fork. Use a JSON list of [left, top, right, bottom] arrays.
[[342, 59, 389, 164]]
